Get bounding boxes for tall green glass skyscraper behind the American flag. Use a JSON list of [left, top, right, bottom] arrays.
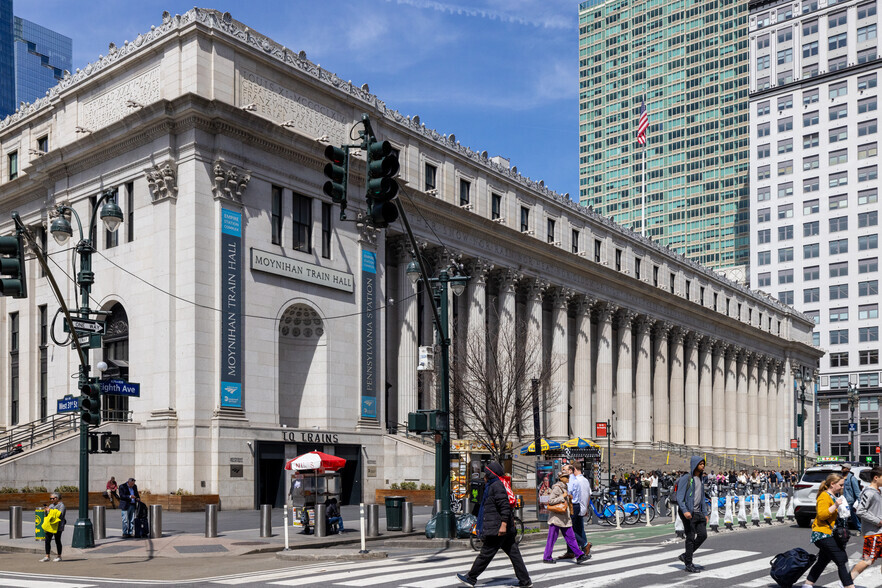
[[579, 0, 750, 272]]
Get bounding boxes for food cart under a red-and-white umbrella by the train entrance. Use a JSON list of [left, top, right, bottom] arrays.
[[285, 451, 346, 533]]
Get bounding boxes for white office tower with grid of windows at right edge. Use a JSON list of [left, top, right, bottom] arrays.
[[750, 0, 882, 459]]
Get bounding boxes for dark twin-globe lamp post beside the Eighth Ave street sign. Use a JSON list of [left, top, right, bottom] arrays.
[[50, 190, 123, 548]]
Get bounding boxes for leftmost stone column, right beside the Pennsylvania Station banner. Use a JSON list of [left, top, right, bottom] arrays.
[[396, 255, 419, 430]]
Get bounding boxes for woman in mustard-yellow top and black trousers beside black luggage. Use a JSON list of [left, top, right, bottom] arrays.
[[803, 474, 854, 588]]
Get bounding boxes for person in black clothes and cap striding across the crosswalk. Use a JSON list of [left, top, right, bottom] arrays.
[[456, 461, 533, 588]]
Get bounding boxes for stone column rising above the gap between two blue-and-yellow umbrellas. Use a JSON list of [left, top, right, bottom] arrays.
[[547, 288, 573, 441]]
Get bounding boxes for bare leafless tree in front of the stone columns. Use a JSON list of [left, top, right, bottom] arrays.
[[451, 308, 568, 460]]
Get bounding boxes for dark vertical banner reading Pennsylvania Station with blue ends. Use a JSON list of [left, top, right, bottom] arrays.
[[361, 250, 378, 419]]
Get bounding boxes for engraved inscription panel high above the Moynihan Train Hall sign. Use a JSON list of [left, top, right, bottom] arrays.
[[240, 70, 349, 145]]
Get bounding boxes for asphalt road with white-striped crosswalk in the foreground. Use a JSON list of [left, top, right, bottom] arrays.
[[0, 525, 882, 588]]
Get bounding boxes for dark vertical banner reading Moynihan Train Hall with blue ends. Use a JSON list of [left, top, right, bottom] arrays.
[[220, 208, 243, 408]]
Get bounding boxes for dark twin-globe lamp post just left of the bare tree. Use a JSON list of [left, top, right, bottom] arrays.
[[406, 261, 469, 539]]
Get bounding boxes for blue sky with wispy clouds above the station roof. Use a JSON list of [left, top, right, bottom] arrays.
[[14, 0, 579, 200]]
